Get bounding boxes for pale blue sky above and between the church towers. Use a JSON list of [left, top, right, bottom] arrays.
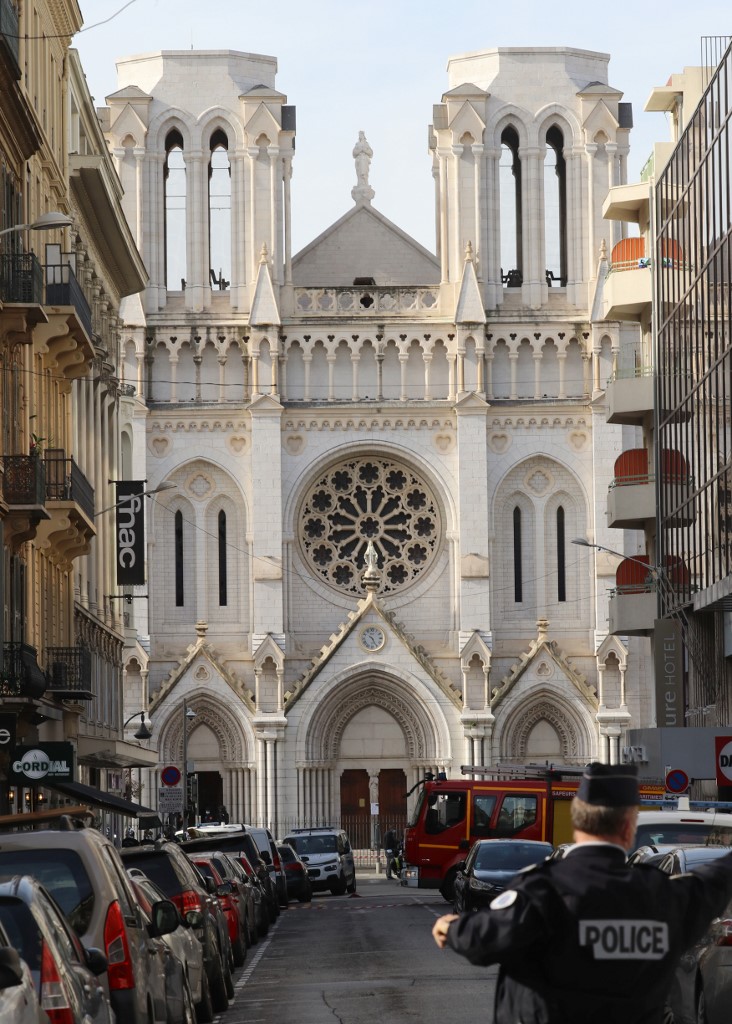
[[73, 0, 732, 253]]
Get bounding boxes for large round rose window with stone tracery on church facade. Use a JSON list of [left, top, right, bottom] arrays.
[[300, 458, 442, 594]]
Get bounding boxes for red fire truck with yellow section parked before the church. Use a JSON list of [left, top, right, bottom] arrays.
[[403, 765, 663, 901]]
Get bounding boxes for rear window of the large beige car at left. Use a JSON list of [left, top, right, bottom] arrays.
[[0, 849, 94, 935]]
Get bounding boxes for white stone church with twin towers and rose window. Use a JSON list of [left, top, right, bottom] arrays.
[[100, 41, 652, 835]]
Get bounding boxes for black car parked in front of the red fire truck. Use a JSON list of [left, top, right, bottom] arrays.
[[453, 839, 554, 913]]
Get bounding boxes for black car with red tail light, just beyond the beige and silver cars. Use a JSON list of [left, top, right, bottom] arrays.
[[122, 840, 233, 1013]]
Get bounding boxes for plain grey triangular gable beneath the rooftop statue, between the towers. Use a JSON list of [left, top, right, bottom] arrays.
[[293, 204, 440, 288]]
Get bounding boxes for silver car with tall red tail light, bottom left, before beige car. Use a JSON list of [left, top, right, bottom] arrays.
[[0, 876, 114, 1024]]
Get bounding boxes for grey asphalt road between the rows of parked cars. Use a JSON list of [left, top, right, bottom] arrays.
[[217, 876, 497, 1024]]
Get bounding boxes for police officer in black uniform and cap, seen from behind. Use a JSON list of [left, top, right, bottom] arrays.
[[432, 764, 732, 1024]]
